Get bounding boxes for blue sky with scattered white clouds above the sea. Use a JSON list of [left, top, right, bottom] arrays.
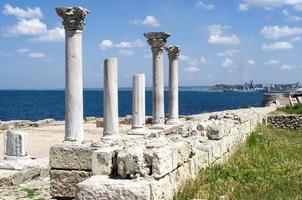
[[0, 0, 302, 89]]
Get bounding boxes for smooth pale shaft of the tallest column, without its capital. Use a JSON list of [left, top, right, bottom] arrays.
[[65, 30, 84, 141]]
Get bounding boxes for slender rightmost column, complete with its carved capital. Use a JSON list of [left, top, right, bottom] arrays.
[[166, 46, 180, 125]]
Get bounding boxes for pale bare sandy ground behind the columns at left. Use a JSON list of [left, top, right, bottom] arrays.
[[0, 122, 130, 160]]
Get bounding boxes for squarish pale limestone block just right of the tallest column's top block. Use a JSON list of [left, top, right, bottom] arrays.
[[92, 147, 117, 175]]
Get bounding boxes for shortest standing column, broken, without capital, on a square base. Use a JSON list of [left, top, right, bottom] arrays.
[[129, 74, 146, 134]]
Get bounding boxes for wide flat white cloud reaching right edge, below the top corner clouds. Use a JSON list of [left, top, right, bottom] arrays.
[[260, 26, 302, 39]]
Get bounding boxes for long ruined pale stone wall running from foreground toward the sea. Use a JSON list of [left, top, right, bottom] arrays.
[[50, 106, 275, 200]]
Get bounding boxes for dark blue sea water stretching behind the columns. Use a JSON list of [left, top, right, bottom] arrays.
[[0, 91, 262, 121]]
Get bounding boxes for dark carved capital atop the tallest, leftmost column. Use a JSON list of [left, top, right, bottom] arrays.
[[56, 7, 89, 31]]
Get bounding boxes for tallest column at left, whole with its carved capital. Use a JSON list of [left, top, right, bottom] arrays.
[[56, 7, 89, 142]]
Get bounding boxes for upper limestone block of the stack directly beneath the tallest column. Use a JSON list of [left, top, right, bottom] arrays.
[[49, 144, 95, 170]]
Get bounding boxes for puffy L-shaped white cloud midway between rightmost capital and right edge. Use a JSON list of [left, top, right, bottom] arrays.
[[208, 24, 240, 45]]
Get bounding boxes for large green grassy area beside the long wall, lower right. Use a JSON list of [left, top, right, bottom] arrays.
[[175, 126, 302, 200]]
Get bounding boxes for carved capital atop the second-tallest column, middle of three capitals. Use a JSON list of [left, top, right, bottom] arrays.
[[144, 32, 170, 54]]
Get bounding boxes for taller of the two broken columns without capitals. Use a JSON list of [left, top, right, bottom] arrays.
[[103, 58, 119, 137]]
